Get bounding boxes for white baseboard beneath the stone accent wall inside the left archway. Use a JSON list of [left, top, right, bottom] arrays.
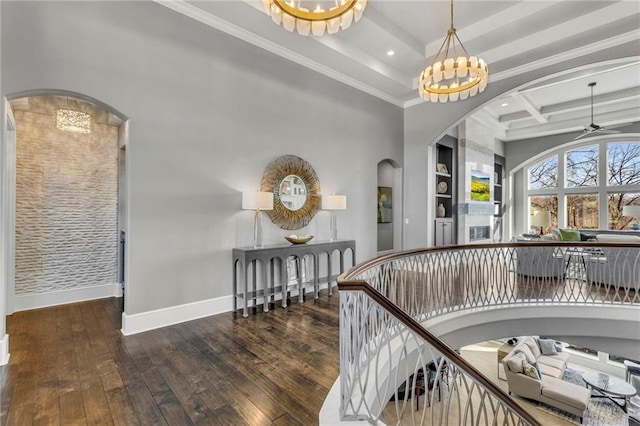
[[13, 283, 122, 312]]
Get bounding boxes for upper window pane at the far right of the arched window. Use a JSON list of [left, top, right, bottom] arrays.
[[607, 142, 640, 185]]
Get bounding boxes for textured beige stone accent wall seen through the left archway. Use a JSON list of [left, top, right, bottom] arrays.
[[15, 110, 118, 295]]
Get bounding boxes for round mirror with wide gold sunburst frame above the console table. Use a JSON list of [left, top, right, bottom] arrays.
[[260, 155, 320, 230]]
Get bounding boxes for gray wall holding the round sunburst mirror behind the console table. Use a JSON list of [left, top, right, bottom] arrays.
[[1, 2, 403, 314]]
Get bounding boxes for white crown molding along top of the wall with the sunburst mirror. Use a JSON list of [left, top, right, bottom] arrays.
[[153, 0, 403, 107]]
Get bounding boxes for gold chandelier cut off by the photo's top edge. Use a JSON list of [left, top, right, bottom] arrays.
[[262, 0, 367, 36]]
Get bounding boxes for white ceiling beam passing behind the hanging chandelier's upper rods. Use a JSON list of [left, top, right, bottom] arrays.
[[424, 1, 554, 58]]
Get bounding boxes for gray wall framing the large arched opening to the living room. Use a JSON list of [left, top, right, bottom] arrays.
[[403, 41, 638, 249]]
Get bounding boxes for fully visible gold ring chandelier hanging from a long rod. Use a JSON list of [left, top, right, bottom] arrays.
[[418, 0, 489, 102]]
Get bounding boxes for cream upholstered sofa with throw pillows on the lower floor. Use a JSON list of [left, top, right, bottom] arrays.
[[502, 337, 591, 422]]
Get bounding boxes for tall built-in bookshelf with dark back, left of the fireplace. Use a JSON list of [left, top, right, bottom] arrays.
[[434, 137, 457, 246]]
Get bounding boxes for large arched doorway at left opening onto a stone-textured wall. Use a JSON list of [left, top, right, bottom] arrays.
[[0, 91, 128, 352]]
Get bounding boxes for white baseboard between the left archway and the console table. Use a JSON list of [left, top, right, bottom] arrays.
[[121, 296, 233, 336]]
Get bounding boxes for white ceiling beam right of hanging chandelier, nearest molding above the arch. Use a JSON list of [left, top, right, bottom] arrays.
[[477, 1, 638, 64]]
